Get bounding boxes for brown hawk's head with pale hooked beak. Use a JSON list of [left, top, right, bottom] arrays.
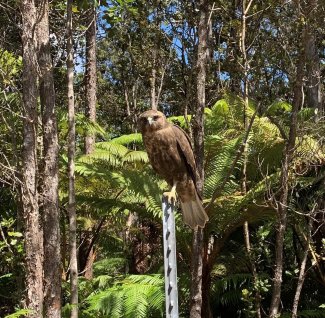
[[138, 110, 168, 133]]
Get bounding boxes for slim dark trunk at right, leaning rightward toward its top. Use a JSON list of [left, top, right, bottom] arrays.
[[269, 18, 305, 318]]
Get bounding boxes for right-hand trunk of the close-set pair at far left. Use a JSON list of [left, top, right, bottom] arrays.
[[37, 0, 61, 318]]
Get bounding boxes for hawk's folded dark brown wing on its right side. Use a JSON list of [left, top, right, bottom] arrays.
[[172, 125, 197, 187]]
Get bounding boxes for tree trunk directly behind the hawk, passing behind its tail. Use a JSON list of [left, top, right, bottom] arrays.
[[190, 0, 209, 318]]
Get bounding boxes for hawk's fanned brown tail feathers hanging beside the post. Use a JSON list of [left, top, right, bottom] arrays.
[[181, 194, 209, 229]]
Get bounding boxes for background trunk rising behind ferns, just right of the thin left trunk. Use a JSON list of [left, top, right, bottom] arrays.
[[85, 7, 97, 154]]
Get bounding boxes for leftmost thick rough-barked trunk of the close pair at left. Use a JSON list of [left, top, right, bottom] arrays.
[[21, 0, 43, 318]]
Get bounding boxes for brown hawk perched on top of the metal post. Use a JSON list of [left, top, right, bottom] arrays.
[[138, 110, 209, 229]]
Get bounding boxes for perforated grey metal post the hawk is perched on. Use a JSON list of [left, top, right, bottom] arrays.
[[162, 197, 178, 318]]
